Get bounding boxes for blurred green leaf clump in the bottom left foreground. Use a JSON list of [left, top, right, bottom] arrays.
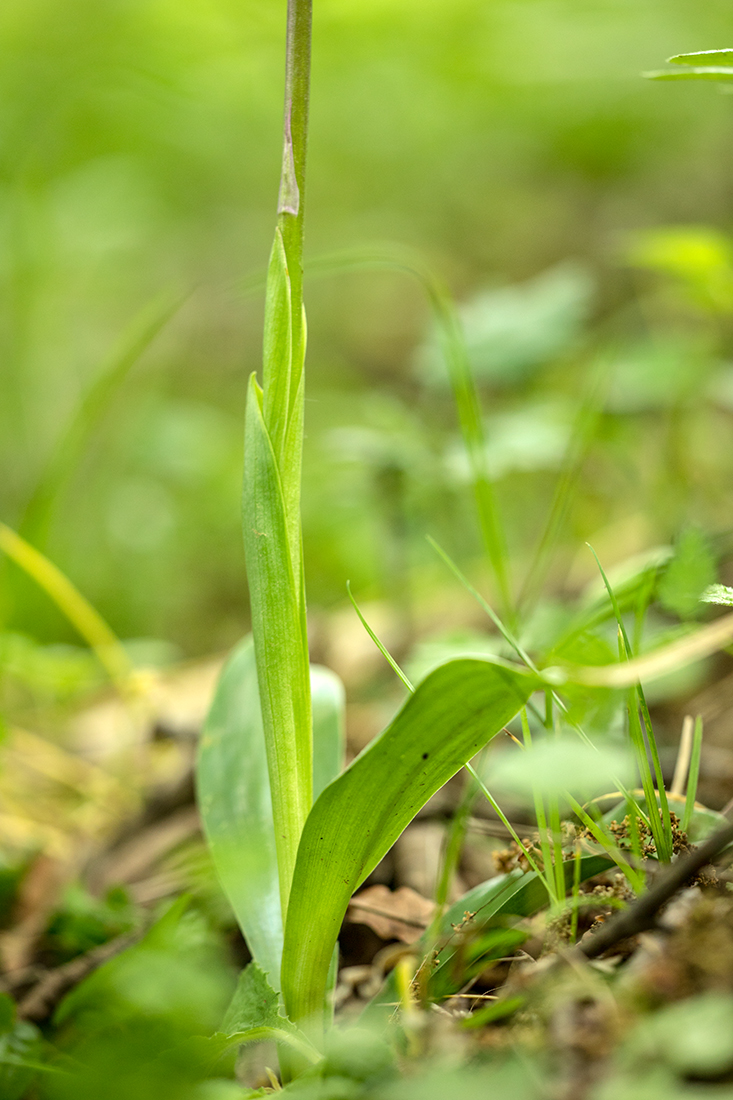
[[42, 898, 234, 1100]]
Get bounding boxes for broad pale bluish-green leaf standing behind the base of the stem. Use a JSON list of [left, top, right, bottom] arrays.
[[197, 637, 344, 989]]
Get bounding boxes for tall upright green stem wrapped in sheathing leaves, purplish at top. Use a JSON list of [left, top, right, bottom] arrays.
[[243, 0, 313, 922]]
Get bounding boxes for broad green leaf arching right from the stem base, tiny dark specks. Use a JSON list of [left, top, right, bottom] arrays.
[[282, 660, 530, 1021]]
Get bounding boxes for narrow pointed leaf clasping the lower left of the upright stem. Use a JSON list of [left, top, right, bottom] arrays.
[[243, 375, 313, 912]]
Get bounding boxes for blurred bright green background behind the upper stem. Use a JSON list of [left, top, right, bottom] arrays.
[[0, 0, 733, 660]]
